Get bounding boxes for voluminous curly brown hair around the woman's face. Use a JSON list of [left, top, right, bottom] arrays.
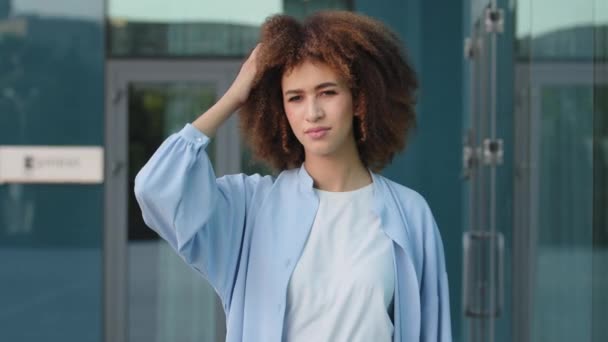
[[239, 11, 418, 172]]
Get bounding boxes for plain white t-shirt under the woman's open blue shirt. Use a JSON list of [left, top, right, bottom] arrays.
[[283, 184, 395, 342]]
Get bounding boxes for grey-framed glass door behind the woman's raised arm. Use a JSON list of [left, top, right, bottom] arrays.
[[104, 61, 241, 342]]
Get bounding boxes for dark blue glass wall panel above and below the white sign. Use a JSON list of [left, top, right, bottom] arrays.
[[0, 0, 104, 342]]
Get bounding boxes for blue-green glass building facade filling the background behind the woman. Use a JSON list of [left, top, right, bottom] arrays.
[[0, 0, 608, 342]]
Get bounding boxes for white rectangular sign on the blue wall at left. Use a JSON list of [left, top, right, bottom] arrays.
[[0, 146, 103, 184]]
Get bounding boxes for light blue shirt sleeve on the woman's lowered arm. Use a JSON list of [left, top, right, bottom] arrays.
[[421, 205, 452, 342]]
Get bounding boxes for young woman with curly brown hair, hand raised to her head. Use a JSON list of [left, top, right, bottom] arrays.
[[135, 12, 451, 342]]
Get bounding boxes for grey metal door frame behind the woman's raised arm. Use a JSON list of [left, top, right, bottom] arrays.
[[103, 59, 241, 342]]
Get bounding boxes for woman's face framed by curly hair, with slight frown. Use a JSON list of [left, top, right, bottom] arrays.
[[281, 61, 357, 162]]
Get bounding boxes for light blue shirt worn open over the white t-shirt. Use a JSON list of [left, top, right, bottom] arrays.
[[135, 124, 452, 342]]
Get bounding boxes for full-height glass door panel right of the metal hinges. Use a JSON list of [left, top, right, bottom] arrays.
[[513, 0, 608, 342]]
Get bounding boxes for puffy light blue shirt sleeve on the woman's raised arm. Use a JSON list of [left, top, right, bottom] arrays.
[[134, 124, 270, 305]]
